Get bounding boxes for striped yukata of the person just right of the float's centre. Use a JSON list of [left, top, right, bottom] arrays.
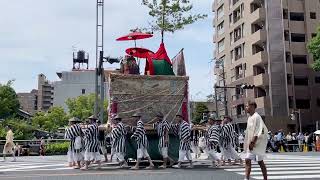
[[153, 120, 170, 158]]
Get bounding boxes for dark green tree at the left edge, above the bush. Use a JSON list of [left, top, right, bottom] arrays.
[[0, 80, 20, 119]]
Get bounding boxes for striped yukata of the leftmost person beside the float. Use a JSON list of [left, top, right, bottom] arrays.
[[66, 124, 83, 162]]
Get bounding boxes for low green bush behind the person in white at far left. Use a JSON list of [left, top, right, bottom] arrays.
[[0, 118, 36, 140]]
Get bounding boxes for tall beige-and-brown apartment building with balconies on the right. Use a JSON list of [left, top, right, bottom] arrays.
[[212, 0, 320, 131]]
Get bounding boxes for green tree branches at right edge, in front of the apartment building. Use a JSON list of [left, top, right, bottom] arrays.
[[307, 27, 320, 71]]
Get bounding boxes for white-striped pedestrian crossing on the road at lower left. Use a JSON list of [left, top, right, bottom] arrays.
[[0, 161, 72, 173]]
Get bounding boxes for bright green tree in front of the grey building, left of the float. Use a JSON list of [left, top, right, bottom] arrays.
[[66, 94, 108, 120]]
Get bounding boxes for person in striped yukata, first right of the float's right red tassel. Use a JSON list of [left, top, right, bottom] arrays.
[[205, 114, 221, 168]]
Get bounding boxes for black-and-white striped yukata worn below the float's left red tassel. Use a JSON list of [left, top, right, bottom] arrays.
[[111, 122, 127, 162]]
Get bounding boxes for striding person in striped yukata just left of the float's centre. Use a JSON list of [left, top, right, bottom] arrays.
[[131, 113, 154, 169]]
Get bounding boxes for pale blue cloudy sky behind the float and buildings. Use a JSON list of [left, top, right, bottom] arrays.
[[0, 0, 214, 99]]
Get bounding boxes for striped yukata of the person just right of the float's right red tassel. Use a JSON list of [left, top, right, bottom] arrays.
[[205, 125, 220, 160]]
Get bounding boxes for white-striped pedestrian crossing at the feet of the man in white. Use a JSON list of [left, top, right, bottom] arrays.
[[225, 154, 320, 180]]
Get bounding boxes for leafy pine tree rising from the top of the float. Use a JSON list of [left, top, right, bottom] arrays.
[[142, 0, 207, 42]]
